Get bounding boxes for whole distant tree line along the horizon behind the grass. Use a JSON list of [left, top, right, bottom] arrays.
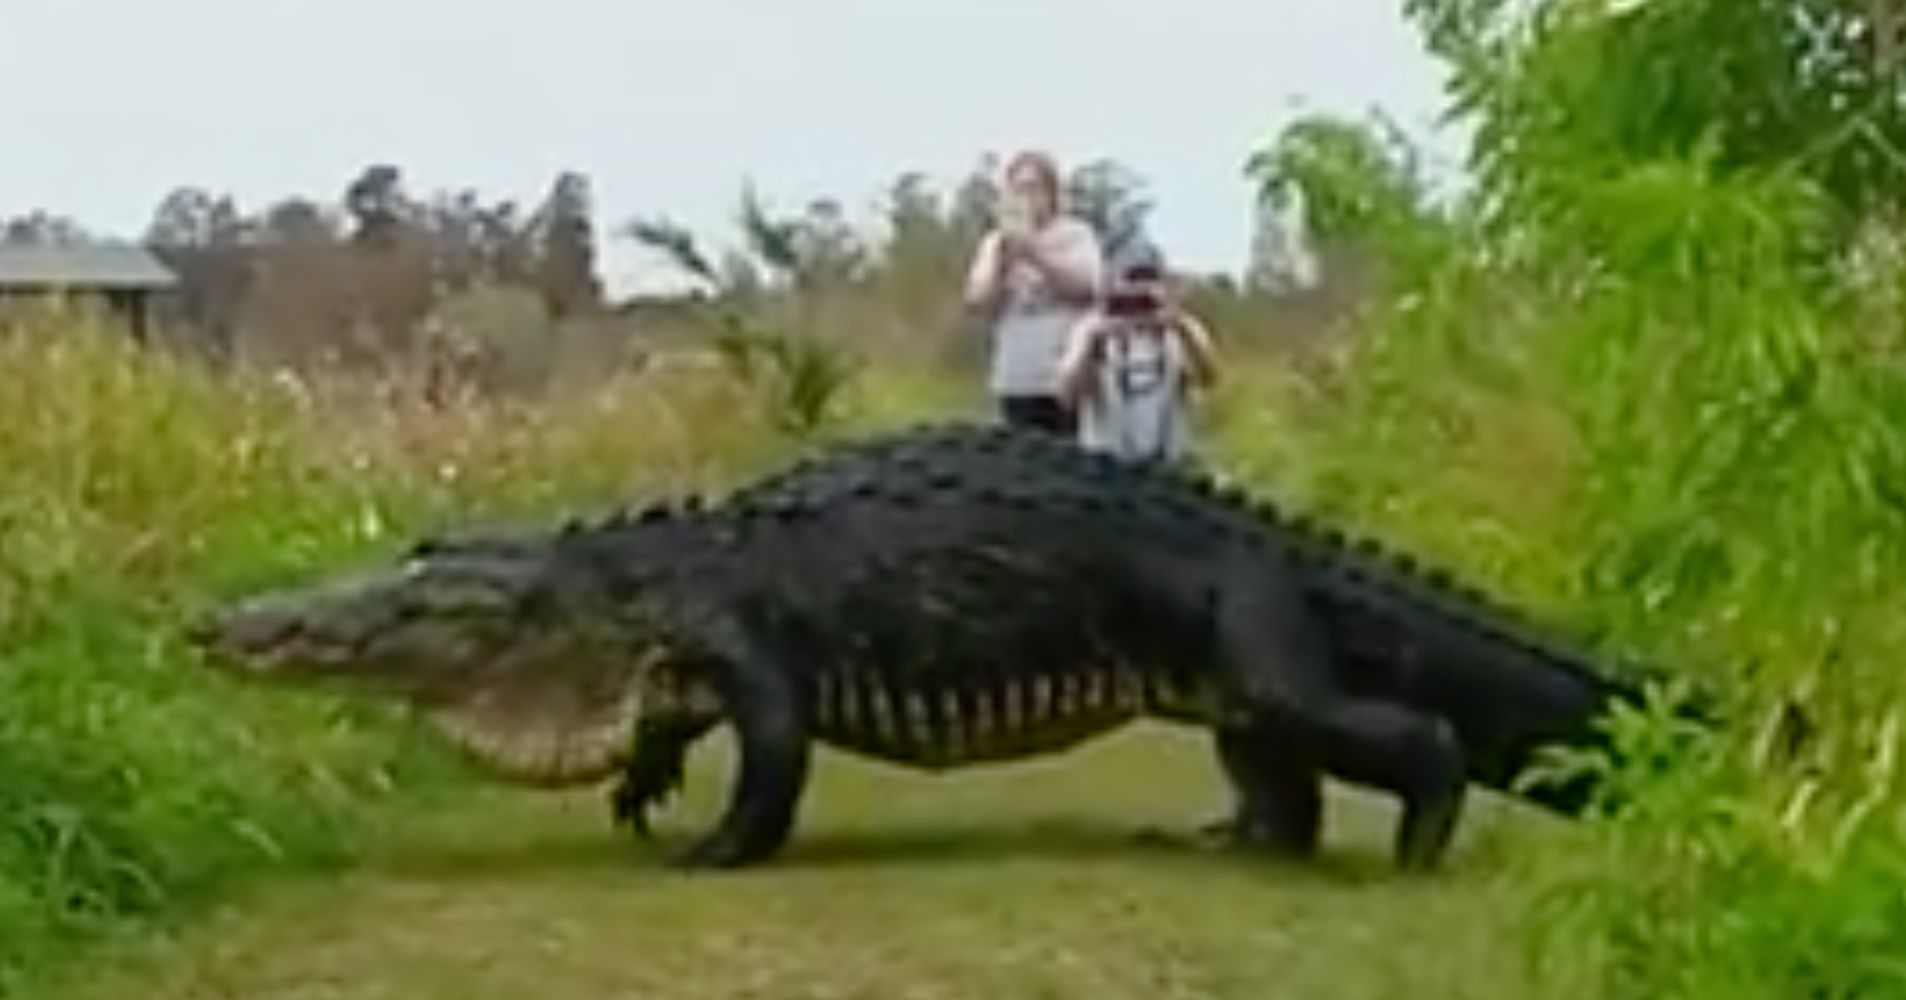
[[0, 152, 1357, 373]]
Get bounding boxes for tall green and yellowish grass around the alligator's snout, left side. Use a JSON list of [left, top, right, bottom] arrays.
[[0, 300, 949, 989]]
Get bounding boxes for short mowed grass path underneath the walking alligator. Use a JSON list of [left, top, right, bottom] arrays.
[[48, 728, 1551, 1000]]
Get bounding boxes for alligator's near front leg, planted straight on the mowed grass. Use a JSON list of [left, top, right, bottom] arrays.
[[673, 623, 810, 869]]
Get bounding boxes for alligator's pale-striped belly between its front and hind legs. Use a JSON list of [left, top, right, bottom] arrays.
[[814, 669, 1195, 770]]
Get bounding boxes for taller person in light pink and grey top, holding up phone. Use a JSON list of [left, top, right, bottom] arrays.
[[966, 152, 1104, 434]]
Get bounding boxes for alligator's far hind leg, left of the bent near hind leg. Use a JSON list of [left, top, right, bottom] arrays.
[[1205, 726, 1323, 857]]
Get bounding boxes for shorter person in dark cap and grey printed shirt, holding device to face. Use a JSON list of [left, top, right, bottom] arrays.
[[1060, 242, 1218, 461]]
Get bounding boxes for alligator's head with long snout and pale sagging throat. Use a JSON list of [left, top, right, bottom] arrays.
[[189, 537, 678, 785]]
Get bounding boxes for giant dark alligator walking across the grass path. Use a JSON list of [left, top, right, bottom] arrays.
[[193, 423, 1637, 869]]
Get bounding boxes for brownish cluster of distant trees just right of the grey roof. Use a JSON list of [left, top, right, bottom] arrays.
[[0, 164, 602, 360]]
